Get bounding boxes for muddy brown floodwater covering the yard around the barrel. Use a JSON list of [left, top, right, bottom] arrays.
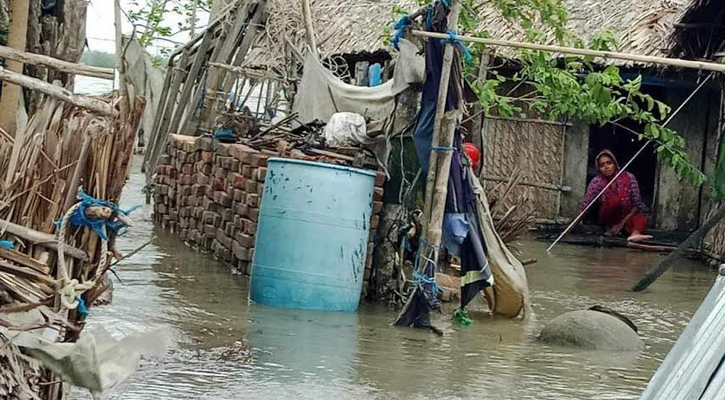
[[70, 159, 715, 400]]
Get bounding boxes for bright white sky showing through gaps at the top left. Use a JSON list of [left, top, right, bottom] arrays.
[[86, 0, 207, 55]]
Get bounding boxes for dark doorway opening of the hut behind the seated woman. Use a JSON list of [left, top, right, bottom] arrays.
[[587, 121, 657, 219]]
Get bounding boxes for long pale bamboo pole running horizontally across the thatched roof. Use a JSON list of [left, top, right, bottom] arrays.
[[411, 30, 725, 72]]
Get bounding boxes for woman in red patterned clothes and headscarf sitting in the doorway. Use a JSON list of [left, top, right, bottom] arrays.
[[582, 150, 652, 242]]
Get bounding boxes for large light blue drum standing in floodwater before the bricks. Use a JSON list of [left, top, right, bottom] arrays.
[[249, 158, 375, 312]]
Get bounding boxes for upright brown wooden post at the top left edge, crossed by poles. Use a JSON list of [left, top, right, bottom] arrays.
[[0, 0, 30, 136]]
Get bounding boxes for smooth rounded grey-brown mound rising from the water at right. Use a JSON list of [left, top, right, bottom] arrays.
[[538, 310, 644, 351]]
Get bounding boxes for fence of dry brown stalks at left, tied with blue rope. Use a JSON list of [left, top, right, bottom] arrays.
[[0, 92, 145, 398]]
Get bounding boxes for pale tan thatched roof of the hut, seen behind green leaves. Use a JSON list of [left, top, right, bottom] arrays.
[[243, 0, 700, 67]]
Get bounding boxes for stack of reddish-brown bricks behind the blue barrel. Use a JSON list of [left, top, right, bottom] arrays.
[[154, 135, 385, 290]]
